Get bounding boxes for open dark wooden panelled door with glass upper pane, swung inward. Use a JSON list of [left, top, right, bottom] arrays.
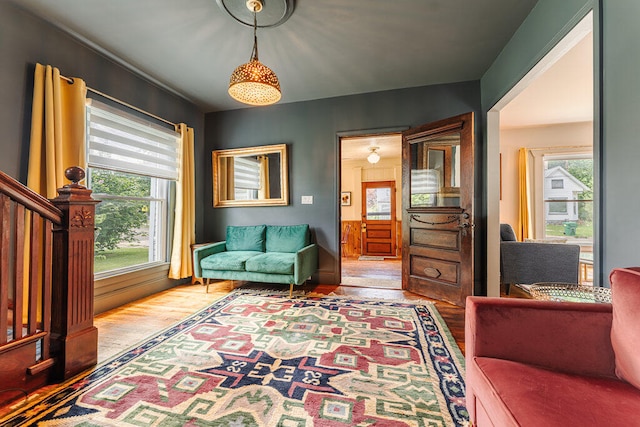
[[402, 113, 474, 306]]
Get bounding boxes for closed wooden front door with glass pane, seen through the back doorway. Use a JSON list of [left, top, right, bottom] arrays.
[[361, 181, 396, 256]]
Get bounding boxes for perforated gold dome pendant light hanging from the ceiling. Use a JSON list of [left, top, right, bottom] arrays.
[[229, 0, 282, 105]]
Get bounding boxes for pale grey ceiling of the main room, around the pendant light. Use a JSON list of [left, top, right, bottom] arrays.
[[11, 0, 536, 112]]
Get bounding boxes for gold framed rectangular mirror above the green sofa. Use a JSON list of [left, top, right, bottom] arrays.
[[212, 144, 289, 208]]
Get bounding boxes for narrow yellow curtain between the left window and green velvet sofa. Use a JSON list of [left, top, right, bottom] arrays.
[[169, 123, 196, 279]]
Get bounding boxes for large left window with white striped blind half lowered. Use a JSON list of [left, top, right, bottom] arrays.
[[87, 100, 179, 276]]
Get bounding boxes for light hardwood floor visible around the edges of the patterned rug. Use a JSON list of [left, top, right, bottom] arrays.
[[94, 281, 464, 362]]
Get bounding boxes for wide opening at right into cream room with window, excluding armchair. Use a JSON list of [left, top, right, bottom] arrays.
[[487, 12, 599, 296]]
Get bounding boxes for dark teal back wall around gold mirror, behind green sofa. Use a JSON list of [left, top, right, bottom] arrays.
[[205, 81, 482, 283]]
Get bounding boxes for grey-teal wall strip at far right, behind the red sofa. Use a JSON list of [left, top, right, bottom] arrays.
[[601, 0, 640, 277]]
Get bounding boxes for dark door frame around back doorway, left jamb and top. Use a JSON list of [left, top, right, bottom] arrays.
[[333, 126, 410, 286]]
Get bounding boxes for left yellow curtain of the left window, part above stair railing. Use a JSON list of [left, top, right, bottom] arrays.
[[27, 64, 87, 198]]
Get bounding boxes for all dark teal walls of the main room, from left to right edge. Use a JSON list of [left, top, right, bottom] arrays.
[[6, 0, 640, 294]]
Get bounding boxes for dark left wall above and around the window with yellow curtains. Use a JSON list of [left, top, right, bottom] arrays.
[[0, 1, 205, 241]]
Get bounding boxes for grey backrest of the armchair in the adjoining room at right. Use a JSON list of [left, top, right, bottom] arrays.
[[500, 242, 580, 285]]
